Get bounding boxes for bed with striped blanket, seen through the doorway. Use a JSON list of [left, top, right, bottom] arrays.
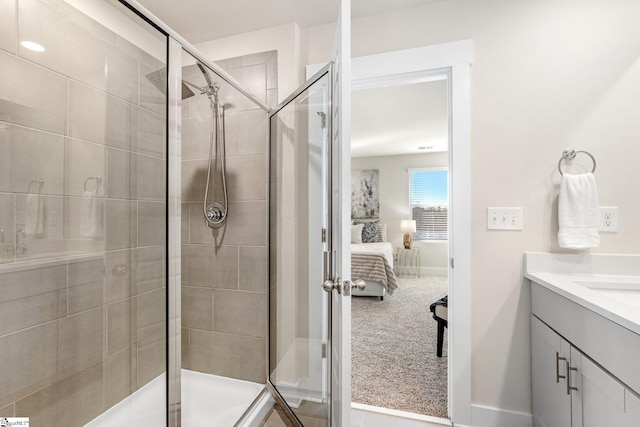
[[351, 242, 398, 300]]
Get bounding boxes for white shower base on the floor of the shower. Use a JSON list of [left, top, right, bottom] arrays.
[[87, 369, 264, 427]]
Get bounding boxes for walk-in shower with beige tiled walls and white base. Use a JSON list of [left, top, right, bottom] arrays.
[[0, 0, 277, 427]]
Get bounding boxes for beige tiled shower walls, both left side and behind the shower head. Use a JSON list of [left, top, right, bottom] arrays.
[[0, 0, 277, 426]]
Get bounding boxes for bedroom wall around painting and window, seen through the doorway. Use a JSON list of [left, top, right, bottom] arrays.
[[351, 153, 449, 276]]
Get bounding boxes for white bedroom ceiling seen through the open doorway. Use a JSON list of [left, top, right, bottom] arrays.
[[351, 80, 449, 157]]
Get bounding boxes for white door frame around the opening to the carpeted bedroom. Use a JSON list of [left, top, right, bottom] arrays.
[[351, 40, 473, 426]]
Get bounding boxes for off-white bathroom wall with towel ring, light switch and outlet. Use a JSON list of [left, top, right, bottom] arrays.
[[303, 0, 640, 425]]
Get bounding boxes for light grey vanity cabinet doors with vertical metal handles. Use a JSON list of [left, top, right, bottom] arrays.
[[531, 315, 640, 427]]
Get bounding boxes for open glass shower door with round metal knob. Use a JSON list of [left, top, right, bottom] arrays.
[[269, 67, 331, 425]]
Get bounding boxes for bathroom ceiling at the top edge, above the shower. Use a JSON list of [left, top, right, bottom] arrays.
[[138, 0, 438, 44]]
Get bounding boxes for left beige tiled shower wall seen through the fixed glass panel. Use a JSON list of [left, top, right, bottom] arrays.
[[0, 0, 166, 427]]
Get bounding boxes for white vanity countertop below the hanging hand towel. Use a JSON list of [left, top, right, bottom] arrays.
[[524, 252, 640, 335]]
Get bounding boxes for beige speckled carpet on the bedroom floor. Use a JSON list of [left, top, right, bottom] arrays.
[[351, 276, 447, 418]]
